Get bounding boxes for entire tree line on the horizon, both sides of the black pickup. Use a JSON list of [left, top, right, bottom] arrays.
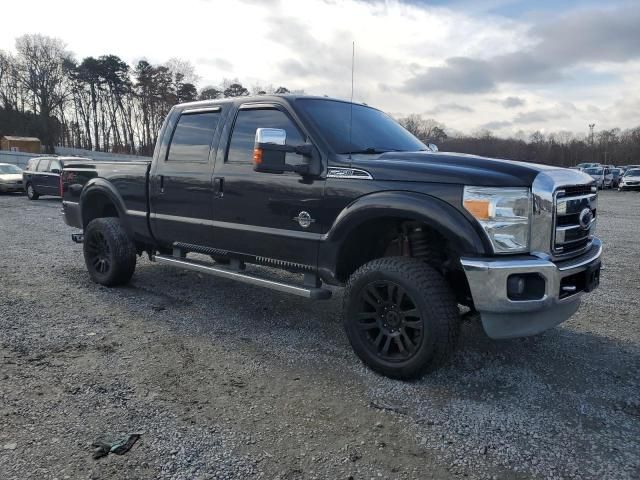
[[0, 34, 640, 166]]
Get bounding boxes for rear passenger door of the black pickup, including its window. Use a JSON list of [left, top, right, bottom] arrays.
[[150, 106, 222, 246]]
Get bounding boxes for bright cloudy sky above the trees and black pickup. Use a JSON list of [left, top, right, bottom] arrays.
[[0, 0, 640, 135]]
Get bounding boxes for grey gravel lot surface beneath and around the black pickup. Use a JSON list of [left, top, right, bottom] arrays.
[[0, 192, 640, 480]]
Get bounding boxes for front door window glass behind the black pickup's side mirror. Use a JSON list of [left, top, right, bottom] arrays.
[[227, 108, 304, 163]]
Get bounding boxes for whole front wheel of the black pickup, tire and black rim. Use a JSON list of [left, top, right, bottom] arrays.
[[343, 257, 460, 380]]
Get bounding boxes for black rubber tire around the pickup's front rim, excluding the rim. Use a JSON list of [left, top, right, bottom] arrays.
[[343, 257, 460, 380]]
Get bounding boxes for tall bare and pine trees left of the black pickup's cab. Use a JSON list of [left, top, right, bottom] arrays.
[[0, 34, 289, 155]]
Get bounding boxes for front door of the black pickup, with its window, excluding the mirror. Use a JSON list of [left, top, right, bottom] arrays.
[[213, 103, 325, 268]]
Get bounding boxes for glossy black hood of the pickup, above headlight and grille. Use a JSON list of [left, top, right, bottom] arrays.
[[346, 152, 592, 187]]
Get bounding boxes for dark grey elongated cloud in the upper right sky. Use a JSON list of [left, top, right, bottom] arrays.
[[404, 4, 640, 94]]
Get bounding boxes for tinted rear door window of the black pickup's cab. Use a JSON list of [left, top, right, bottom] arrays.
[[167, 111, 220, 162]]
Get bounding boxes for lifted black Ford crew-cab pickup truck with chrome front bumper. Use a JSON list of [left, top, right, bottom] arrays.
[[62, 95, 602, 379]]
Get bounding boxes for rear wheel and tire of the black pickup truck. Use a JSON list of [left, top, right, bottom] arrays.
[[82, 217, 136, 287]]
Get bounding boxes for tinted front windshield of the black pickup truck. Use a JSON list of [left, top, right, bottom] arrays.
[[297, 98, 427, 154]]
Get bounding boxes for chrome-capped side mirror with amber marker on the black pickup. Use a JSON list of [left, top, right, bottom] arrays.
[[253, 128, 319, 175]]
